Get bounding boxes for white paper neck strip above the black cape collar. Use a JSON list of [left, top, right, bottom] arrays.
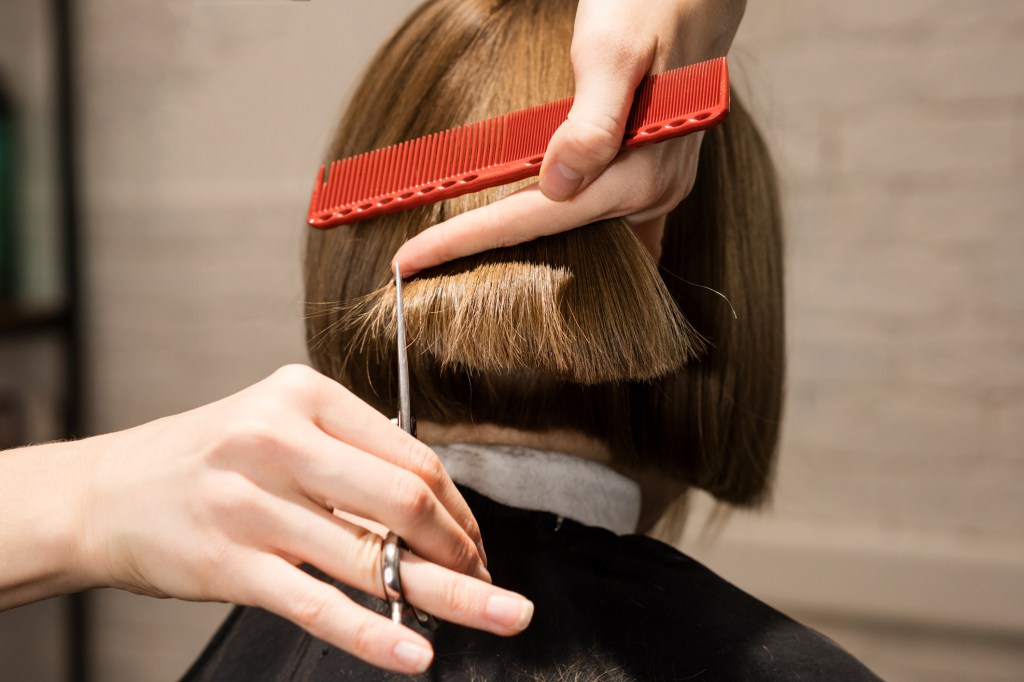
[[430, 443, 640, 535]]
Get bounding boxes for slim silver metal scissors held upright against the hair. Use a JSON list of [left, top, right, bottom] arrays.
[[381, 263, 437, 630]]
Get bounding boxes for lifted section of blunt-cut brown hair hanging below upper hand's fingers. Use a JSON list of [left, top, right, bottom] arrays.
[[342, 220, 703, 385]]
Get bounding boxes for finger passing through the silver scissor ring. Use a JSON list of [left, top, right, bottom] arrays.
[[264, 497, 534, 636]]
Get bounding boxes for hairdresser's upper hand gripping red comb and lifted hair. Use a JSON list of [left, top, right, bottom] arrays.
[[395, 0, 745, 274]]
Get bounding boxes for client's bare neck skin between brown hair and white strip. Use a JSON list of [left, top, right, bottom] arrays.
[[417, 422, 686, 532]]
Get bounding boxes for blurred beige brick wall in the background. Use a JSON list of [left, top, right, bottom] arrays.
[[0, 0, 1024, 680]]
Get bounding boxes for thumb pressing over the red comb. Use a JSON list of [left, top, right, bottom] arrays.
[[541, 37, 650, 202]]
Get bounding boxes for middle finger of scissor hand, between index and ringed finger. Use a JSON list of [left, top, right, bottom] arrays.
[[295, 425, 490, 581]]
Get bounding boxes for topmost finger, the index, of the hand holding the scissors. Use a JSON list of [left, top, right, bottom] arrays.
[[288, 366, 487, 564]]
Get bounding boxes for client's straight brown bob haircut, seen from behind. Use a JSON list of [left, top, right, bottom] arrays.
[[305, 0, 784, 505]]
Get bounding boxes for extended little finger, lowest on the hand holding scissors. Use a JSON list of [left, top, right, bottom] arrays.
[[238, 554, 433, 673]]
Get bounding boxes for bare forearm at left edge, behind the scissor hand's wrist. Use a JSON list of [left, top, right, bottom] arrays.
[[0, 439, 95, 610]]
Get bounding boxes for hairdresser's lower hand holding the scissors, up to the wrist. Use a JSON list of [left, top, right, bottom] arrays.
[[6, 366, 532, 673]]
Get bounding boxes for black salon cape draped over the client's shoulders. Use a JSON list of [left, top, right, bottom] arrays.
[[184, 488, 878, 682]]
